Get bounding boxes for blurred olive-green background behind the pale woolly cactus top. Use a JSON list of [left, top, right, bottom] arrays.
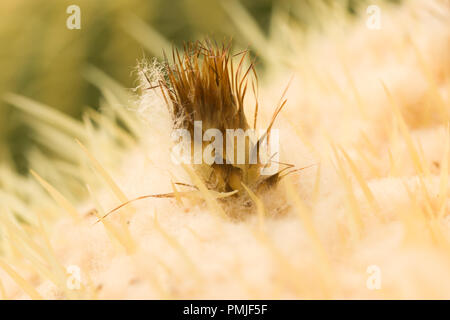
[[0, 0, 398, 173]]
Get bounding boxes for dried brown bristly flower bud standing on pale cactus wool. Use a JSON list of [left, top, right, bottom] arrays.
[[156, 40, 286, 192]]
